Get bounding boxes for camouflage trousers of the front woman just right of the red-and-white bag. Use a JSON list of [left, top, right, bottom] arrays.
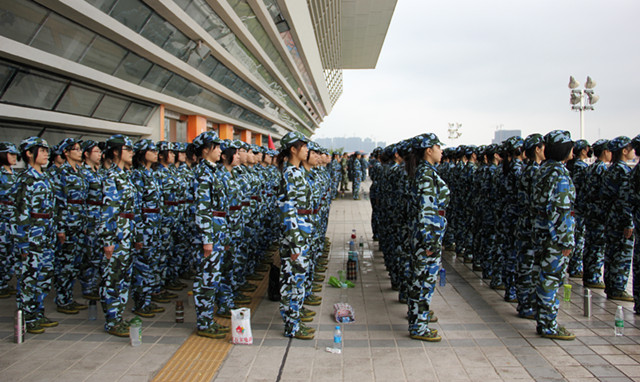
[[280, 254, 309, 337]]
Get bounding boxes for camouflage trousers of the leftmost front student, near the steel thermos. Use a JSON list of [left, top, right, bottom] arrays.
[[16, 248, 55, 323]]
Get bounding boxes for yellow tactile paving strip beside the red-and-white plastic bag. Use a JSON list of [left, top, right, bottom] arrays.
[[153, 262, 269, 382]]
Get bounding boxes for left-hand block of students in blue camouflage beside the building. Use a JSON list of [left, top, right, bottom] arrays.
[[0, 132, 338, 338]]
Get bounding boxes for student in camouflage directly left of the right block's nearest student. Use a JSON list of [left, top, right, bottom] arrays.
[[516, 134, 545, 319]]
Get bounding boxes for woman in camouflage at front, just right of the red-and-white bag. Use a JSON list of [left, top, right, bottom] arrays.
[[277, 132, 314, 339]]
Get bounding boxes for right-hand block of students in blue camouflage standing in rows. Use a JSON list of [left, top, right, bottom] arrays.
[[369, 130, 640, 341]]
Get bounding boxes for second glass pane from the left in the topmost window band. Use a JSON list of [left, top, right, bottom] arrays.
[[31, 14, 95, 61]]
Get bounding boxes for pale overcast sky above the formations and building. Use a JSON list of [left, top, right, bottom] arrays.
[[314, 0, 640, 146]]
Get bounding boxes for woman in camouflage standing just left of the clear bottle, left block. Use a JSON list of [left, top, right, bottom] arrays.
[[100, 134, 142, 337]]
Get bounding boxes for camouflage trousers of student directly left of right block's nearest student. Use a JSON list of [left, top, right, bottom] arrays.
[[516, 248, 537, 317]]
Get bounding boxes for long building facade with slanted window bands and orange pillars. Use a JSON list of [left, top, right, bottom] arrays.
[[0, 0, 396, 145]]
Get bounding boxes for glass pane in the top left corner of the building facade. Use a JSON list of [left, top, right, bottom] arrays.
[[0, 0, 47, 44]]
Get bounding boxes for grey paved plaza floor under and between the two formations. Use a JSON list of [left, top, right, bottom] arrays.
[[0, 184, 640, 382]]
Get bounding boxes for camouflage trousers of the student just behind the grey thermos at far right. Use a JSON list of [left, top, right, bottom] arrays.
[[582, 220, 607, 284]]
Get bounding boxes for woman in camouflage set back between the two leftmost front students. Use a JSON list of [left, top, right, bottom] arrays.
[[54, 138, 89, 314]]
